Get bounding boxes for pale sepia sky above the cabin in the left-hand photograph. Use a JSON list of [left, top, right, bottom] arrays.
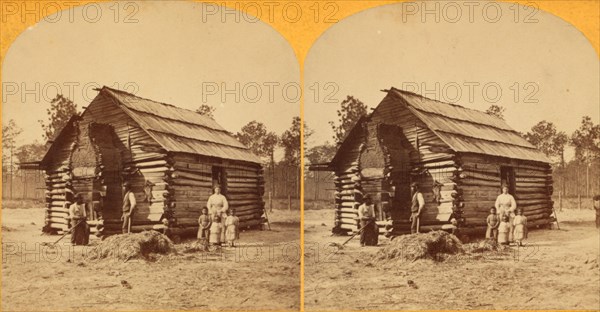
[[2, 1, 300, 161]]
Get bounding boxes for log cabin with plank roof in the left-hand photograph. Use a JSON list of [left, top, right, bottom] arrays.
[[39, 87, 266, 235]]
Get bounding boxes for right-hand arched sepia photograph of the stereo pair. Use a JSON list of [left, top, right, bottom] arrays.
[[304, 1, 600, 311]]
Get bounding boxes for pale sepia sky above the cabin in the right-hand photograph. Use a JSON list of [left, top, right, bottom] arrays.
[[305, 1, 600, 163]]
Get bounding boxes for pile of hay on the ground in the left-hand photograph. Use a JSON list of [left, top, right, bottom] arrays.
[[89, 231, 175, 261]]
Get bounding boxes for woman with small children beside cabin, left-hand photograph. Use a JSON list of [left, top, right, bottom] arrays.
[[198, 186, 240, 247]]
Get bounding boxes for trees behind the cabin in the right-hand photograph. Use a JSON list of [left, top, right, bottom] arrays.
[[305, 95, 600, 201]]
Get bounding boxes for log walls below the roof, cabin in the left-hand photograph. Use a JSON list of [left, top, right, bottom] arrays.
[[44, 93, 264, 234]]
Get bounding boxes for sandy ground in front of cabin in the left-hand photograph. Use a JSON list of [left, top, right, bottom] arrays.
[[2, 209, 300, 311]]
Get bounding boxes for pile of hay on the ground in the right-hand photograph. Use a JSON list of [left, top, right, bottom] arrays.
[[374, 231, 464, 262]]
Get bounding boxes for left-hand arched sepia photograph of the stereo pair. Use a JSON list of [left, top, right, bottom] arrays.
[[2, 1, 301, 311]]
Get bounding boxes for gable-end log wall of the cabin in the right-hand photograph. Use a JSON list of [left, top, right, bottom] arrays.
[[334, 96, 462, 235]]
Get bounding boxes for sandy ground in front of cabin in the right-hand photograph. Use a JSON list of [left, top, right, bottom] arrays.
[[305, 209, 600, 310]]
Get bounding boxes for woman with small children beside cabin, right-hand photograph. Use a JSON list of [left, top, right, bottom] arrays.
[[485, 186, 527, 246]]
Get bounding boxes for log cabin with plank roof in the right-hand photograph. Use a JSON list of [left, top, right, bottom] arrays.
[[309, 88, 553, 235]]
